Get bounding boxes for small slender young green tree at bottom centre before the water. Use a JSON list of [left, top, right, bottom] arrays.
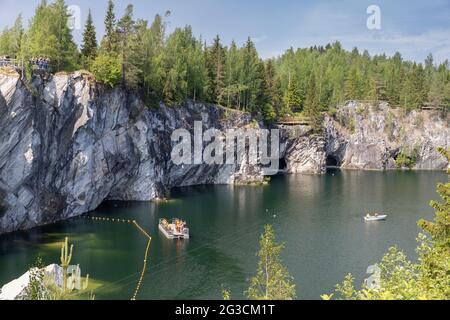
[[246, 225, 296, 300]]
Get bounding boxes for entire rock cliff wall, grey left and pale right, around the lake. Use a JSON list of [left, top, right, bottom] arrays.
[[0, 73, 449, 234]]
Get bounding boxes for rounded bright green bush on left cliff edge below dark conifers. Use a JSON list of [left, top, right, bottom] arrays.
[[91, 53, 122, 87]]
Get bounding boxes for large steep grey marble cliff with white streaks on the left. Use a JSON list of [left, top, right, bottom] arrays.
[[0, 73, 264, 233]]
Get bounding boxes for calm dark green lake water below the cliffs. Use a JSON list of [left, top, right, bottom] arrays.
[[0, 170, 448, 299]]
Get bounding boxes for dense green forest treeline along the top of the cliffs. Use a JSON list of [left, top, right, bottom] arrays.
[[0, 0, 450, 121]]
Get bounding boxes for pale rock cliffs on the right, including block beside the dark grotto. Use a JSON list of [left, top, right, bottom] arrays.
[[281, 102, 450, 174]]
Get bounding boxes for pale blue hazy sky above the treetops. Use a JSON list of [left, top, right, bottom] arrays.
[[0, 0, 450, 62]]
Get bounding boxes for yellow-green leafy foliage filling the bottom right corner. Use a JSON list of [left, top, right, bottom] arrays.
[[322, 184, 450, 300]]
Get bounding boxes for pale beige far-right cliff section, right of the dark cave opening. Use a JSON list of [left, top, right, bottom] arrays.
[[324, 102, 450, 170]]
